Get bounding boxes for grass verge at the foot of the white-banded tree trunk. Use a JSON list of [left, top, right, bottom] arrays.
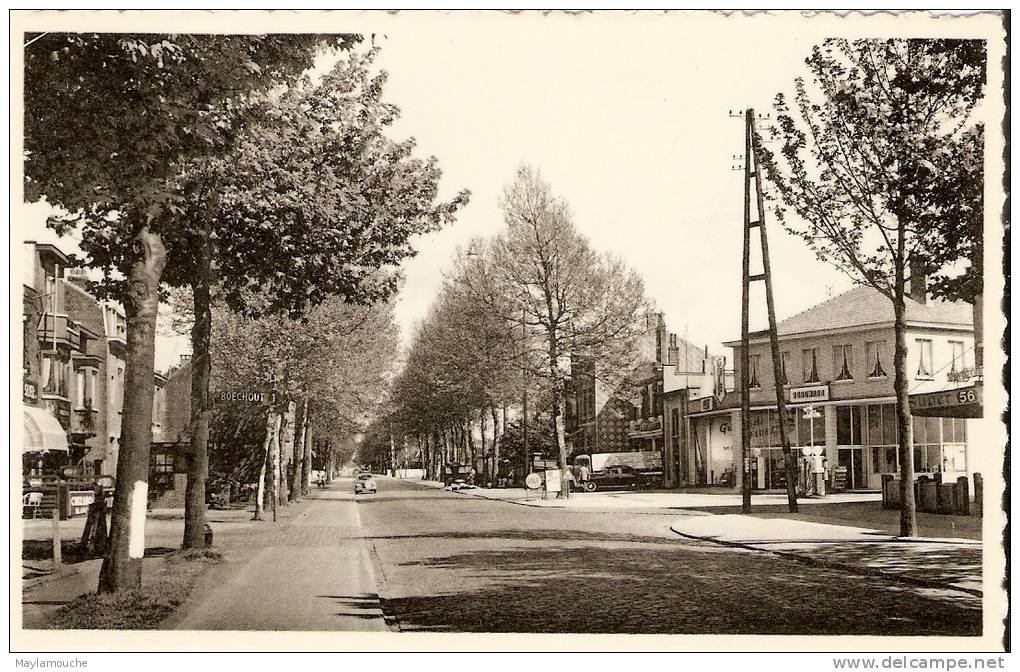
[[47, 549, 222, 630]]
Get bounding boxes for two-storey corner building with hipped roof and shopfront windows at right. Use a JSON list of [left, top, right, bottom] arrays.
[[689, 288, 974, 489]]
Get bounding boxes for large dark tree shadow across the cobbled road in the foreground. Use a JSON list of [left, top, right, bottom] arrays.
[[384, 542, 981, 636]]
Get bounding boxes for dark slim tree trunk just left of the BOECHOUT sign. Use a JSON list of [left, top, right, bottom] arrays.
[[183, 237, 212, 549]]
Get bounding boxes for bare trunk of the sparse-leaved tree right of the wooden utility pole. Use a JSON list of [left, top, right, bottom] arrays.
[[893, 255, 917, 536]]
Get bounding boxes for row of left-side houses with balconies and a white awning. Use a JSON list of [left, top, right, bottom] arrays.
[[20, 242, 190, 509]]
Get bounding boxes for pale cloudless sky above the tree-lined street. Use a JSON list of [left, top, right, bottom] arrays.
[[19, 13, 999, 368]]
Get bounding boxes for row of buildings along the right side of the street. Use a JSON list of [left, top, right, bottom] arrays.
[[567, 277, 980, 490]]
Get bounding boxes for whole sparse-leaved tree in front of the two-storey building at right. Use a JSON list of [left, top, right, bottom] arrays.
[[755, 39, 985, 536]]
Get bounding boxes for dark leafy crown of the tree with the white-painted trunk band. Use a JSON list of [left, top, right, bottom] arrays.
[[24, 33, 360, 296]]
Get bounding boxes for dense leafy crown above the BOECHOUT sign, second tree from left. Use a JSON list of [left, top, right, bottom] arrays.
[[166, 50, 468, 317]]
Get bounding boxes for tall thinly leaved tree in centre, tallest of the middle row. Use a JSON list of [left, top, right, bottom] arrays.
[[478, 166, 648, 497]]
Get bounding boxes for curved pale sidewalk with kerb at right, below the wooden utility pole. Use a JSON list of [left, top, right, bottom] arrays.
[[671, 514, 981, 597]]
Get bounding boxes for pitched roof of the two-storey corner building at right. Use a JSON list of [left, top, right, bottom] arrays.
[[776, 287, 974, 335]]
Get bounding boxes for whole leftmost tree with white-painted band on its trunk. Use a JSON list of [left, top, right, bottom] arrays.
[[24, 33, 349, 591]]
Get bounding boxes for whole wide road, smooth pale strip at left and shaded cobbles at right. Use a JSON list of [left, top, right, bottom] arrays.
[[170, 478, 981, 635]]
